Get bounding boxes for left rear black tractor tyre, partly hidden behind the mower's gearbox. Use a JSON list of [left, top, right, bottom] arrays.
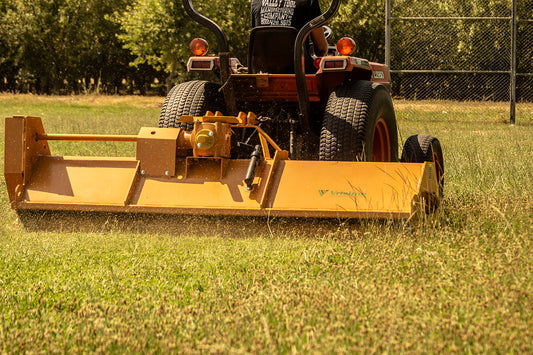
[[159, 80, 225, 130]]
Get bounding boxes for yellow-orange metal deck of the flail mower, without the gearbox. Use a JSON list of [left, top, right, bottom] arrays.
[[5, 118, 439, 218]]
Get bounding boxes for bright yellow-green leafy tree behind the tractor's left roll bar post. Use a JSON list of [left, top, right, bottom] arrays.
[[116, 0, 251, 87]]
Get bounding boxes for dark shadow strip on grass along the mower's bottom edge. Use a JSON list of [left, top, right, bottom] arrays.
[[14, 210, 406, 239]]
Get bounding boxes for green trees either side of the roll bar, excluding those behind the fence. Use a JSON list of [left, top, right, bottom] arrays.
[[0, 0, 383, 94]]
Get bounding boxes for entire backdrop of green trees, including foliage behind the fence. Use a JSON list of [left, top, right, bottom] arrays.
[[0, 0, 533, 98]]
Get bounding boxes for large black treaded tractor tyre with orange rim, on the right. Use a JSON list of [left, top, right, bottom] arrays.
[[319, 81, 398, 162]]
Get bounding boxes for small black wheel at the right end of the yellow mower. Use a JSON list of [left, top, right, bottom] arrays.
[[400, 134, 444, 195]]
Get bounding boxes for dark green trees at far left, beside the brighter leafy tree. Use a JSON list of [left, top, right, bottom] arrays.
[[0, 0, 140, 94]]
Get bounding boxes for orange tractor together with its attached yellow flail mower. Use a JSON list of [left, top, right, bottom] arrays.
[[4, 0, 444, 218]]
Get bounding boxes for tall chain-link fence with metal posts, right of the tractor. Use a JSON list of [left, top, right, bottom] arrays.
[[385, 0, 533, 123]]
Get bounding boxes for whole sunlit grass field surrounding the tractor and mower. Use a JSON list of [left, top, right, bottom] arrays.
[[0, 95, 533, 354]]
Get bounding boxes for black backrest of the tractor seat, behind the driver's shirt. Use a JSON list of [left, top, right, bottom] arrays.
[[248, 26, 298, 74]]
